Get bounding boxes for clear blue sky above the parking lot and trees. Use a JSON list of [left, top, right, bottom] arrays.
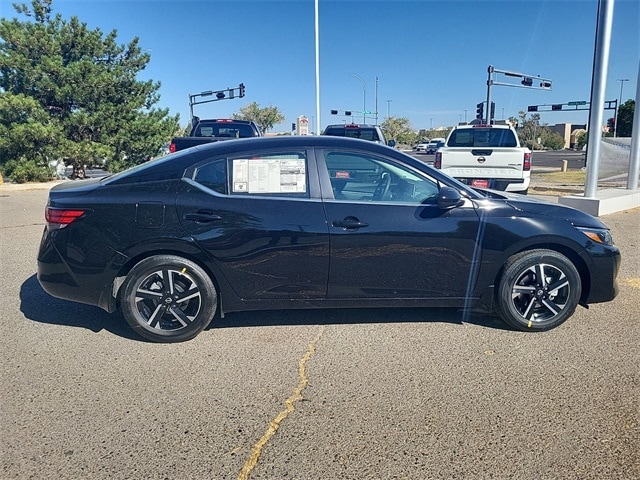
[[0, 0, 640, 132]]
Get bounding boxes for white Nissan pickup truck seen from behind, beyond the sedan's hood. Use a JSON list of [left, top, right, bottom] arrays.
[[434, 125, 531, 194]]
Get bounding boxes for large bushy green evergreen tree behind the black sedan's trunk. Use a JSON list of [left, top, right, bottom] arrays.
[[0, 0, 179, 180]]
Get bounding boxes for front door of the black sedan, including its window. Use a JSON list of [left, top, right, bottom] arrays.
[[317, 149, 480, 304]]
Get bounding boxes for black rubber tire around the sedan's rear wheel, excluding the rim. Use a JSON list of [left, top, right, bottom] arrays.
[[121, 255, 218, 343]]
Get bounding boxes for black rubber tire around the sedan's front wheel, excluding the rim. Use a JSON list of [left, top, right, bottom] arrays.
[[496, 249, 582, 331]]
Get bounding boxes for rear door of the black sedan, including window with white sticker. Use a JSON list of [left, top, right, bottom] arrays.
[[177, 149, 329, 300]]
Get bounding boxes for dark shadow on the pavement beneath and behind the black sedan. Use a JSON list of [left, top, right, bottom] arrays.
[[20, 275, 510, 343]]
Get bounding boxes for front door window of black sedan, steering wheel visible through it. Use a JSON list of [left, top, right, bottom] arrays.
[[324, 151, 440, 204]]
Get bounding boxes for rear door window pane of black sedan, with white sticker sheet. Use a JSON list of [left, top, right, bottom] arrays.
[[228, 151, 309, 198]]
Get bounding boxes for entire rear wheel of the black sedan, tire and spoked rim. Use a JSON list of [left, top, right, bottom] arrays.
[[121, 255, 218, 343]]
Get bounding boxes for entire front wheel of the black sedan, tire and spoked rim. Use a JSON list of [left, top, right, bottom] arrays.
[[497, 249, 582, 331]]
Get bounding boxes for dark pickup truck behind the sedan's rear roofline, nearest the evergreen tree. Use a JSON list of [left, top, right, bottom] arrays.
[[169, 117, 262, 153]]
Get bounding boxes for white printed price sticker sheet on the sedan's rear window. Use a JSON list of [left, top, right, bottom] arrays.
[[233, 158, 307, 194]]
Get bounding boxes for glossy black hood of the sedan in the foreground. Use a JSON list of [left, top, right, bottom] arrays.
[[483, 190, 607, 228]]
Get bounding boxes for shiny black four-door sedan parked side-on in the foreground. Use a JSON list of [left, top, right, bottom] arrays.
[[38, 136, 620, 342]]
